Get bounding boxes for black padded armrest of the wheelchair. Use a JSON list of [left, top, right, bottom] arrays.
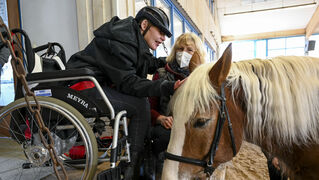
[[26, 68, 95, 81]]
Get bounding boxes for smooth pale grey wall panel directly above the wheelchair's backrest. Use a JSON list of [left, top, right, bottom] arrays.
[[20, 0, 79, 59]]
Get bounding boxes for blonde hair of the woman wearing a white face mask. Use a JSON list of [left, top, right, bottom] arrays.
[[166, 33, 206, 64]]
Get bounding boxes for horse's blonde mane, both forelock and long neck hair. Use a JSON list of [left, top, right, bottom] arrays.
[[171, 56, 319, 145]]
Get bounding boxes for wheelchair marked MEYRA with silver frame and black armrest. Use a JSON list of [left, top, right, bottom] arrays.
[[0, 29, 130, 180]]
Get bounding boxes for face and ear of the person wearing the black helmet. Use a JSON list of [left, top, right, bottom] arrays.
[[141, 20, 165, 50]]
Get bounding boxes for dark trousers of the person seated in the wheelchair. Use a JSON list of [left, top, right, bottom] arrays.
[[92, 85, 151, 152]]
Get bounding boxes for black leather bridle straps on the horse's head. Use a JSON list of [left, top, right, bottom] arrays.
[[165, 83, 237, 177]]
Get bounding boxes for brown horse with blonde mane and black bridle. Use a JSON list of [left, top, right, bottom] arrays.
[[162, 44, 319, 180]]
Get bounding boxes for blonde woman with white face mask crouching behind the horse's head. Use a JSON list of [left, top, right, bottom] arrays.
[[149, 33, 206, 179]]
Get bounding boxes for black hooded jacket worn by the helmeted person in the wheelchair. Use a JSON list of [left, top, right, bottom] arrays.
[[67, 17, 174, 97]]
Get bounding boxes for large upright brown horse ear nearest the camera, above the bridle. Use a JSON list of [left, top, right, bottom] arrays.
[[209, 43, 232, 87]]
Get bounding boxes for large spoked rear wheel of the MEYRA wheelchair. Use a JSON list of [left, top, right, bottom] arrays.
[[0, 97, 98, 180]]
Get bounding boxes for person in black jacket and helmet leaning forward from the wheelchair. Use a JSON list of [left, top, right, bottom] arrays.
[[67, 6, 182, 179]]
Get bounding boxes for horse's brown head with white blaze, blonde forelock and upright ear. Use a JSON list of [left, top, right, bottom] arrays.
[[162, 45, 245, 179]]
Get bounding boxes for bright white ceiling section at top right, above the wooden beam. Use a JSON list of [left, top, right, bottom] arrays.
[[215, 0, 319, 40]]
